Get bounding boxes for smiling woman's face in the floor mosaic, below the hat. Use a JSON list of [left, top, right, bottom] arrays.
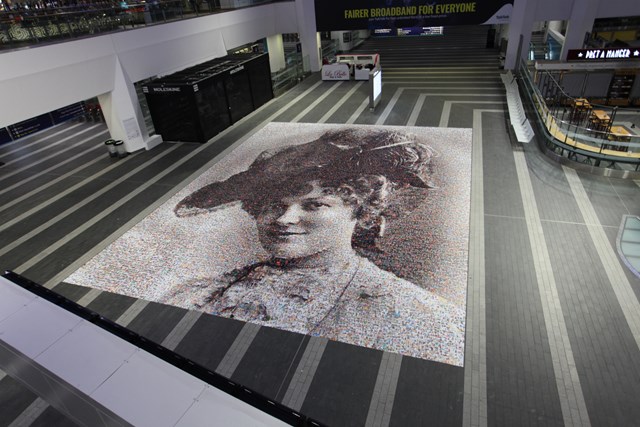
[[256, 182, 356, 259]]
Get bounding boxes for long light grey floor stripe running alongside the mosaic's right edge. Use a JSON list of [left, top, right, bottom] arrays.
[[462, 110, 487, 427]]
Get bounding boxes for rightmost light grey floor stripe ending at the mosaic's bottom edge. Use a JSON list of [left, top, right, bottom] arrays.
[[365, 352, 402, 427]]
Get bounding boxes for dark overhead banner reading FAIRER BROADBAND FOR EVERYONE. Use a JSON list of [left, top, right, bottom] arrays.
[[315, 0, 513, 31]]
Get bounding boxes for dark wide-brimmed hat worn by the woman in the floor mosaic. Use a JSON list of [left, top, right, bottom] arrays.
[[175, 128, 433, 217]]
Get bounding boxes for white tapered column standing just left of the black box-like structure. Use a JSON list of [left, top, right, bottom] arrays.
[[98, 59, 162, 153]]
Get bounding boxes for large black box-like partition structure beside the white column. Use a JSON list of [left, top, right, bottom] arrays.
[[142, 54, 273, 142]]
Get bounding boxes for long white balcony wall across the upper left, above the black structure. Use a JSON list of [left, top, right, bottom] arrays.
[[0, 2, 298, 127]]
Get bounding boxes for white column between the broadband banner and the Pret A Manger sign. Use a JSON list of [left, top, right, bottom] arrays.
[[504, 0, 536, 70]]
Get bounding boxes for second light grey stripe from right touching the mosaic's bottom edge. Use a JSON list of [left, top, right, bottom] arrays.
[[282, 337, 329, 411]]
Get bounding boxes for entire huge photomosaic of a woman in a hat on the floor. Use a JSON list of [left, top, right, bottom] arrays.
[[65, 123, 471, 366]]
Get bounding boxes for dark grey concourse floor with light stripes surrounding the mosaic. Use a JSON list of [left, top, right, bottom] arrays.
[[0, 27, 640, 426]]
